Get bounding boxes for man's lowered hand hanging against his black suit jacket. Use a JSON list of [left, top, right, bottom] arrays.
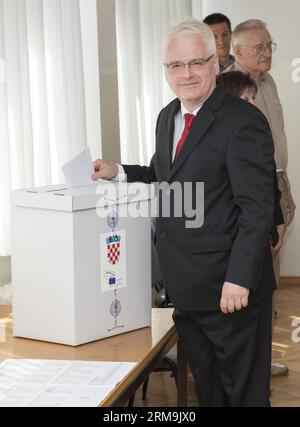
[[220, 282, 250, 314]]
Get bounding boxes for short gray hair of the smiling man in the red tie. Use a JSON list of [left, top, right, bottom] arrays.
[[162, 18, 217, 55]]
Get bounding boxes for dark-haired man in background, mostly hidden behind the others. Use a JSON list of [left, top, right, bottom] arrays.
[[203, 13, 234, 73]]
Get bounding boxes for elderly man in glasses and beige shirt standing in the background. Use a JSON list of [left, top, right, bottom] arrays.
[[225, 19, 296, 375]]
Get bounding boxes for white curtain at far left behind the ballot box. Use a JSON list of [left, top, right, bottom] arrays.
[[0, 0, 101, 256]]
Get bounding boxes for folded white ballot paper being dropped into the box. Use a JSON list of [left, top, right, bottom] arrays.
[[62, 147, 94, 188]]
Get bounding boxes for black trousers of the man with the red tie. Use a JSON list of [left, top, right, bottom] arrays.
[[174, 298, 272, 406]]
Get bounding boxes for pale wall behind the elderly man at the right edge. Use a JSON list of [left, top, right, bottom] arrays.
[[203, 0, 300, 276]]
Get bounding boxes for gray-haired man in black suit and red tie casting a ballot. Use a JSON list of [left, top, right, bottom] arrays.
[[93, 20, 275, 406]]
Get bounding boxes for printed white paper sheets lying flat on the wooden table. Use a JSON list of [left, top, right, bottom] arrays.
[[0, 359, 136, 407]]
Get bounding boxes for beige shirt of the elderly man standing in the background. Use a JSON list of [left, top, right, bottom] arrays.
[[225, 62, 288, 172]]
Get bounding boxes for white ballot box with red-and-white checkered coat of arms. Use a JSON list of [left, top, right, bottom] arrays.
[[12, 182, 153, 346]]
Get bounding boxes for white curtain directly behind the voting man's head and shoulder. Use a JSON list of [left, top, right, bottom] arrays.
[[116, 0, 202, 164]]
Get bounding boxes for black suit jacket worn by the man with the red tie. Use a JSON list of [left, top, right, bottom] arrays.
[[123, 86, 275, 311]]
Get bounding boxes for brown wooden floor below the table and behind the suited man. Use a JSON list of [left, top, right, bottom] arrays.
[[134, 285, 300, 407]]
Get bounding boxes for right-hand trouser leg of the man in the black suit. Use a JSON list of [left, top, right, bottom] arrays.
[[215, 298, 272, 407]]
